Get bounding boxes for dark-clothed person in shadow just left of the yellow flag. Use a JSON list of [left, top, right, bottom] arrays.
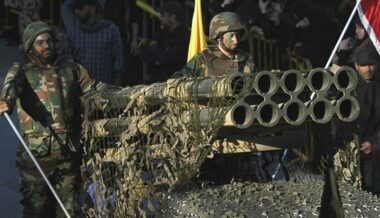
[[139, 2, 190, 83]]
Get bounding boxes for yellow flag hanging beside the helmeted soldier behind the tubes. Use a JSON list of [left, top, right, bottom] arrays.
[[187, 0, 207, 61]]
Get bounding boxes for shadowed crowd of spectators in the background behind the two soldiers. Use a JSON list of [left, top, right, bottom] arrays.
[[2, 0, 361, 85]]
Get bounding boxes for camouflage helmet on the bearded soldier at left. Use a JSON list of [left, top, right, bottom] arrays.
[[22, 21, 53, 52]]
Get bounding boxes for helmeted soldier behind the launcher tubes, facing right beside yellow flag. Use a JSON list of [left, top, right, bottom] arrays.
[[173, 12, 254, 77]]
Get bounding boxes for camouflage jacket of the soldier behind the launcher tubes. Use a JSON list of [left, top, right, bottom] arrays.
[[173, 45, 255, 78]]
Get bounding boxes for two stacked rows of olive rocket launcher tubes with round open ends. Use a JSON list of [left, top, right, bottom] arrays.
[[85, 66, 360, 135]]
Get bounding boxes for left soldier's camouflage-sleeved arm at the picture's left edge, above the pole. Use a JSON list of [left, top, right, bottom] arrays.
[[0, 65, 25, 114]]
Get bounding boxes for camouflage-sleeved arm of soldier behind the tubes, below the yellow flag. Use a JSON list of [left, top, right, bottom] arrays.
[[171, 53, 205, 78]]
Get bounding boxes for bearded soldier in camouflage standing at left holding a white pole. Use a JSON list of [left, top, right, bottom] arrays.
[[0, 21, 100, 217]]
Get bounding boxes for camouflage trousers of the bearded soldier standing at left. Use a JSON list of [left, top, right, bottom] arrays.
[[16, 134, 79, 217]]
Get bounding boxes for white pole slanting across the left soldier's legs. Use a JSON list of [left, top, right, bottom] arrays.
[[4, 113, 71, 218]]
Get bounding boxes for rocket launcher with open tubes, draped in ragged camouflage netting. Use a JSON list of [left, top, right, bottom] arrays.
[[75, 66, 380, 217]]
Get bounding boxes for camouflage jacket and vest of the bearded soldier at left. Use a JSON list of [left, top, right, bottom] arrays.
[[1, 60, 94, 135]]
